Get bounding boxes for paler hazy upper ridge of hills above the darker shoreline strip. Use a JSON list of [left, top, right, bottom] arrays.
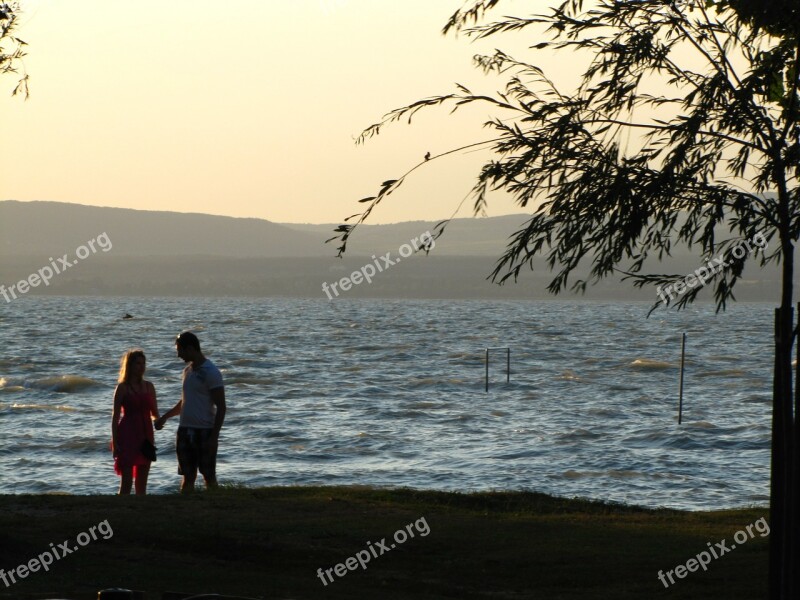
[[0, 200, 529, 258]]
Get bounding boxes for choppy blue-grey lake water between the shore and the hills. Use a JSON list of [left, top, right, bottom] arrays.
[[0, 297, 773, 509]]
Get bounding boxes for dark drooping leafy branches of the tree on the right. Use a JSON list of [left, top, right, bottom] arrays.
[[333, 0, 800, 308]]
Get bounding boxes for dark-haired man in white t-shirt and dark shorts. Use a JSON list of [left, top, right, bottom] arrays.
[[155, 331, 226, 493]]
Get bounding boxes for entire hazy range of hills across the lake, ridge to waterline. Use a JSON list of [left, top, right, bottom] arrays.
[[0, 200, 780, 306]]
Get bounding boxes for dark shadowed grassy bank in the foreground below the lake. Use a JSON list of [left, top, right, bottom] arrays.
[[0, 487, 769, 600]]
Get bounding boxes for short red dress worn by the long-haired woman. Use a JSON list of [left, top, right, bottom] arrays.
[[114, 386, 156, 475]]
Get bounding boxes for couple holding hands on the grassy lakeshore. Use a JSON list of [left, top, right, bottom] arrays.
[[111, 331, 226, 494]]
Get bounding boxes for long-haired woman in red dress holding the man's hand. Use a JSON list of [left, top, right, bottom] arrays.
[[111, 349, 159, 495]]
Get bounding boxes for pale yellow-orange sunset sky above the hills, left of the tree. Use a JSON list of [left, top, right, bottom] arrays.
[[0, 0, 588, 223]]
